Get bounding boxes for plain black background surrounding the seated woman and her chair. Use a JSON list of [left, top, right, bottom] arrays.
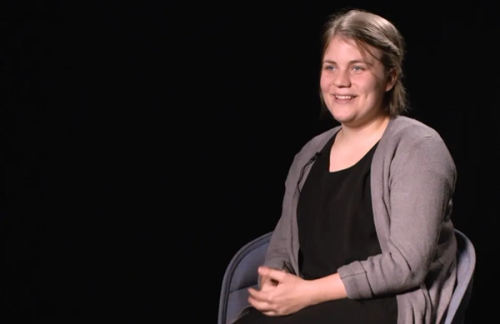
[[0, 0, 500, 323]]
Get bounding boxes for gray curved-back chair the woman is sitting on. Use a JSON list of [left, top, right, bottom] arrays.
[[217, 230, 476, 324]]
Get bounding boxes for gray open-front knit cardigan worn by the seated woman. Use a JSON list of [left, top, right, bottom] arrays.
[[265, 116, 456, 324]]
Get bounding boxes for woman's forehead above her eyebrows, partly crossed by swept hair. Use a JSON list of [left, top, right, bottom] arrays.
[[323, 36, 382, 62]]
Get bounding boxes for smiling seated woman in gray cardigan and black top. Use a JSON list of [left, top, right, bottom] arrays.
[[236, 10, 456, 324]]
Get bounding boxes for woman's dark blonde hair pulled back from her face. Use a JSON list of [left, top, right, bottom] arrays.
[[321, 9, 407, 117]]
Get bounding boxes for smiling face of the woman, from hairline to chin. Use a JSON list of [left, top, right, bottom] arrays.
[[320, 36, 396, 127]]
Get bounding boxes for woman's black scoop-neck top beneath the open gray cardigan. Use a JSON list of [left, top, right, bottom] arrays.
[[297, 132, 397, 324]]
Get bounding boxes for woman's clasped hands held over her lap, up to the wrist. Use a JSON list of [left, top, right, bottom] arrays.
[[248, 267, 311, 316]]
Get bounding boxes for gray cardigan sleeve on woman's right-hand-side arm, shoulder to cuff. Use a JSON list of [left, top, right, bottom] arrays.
[[338, 136, 455, 299]]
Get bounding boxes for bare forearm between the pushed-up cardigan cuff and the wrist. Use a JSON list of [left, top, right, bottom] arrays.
[[306, 273, 347, 305]]
